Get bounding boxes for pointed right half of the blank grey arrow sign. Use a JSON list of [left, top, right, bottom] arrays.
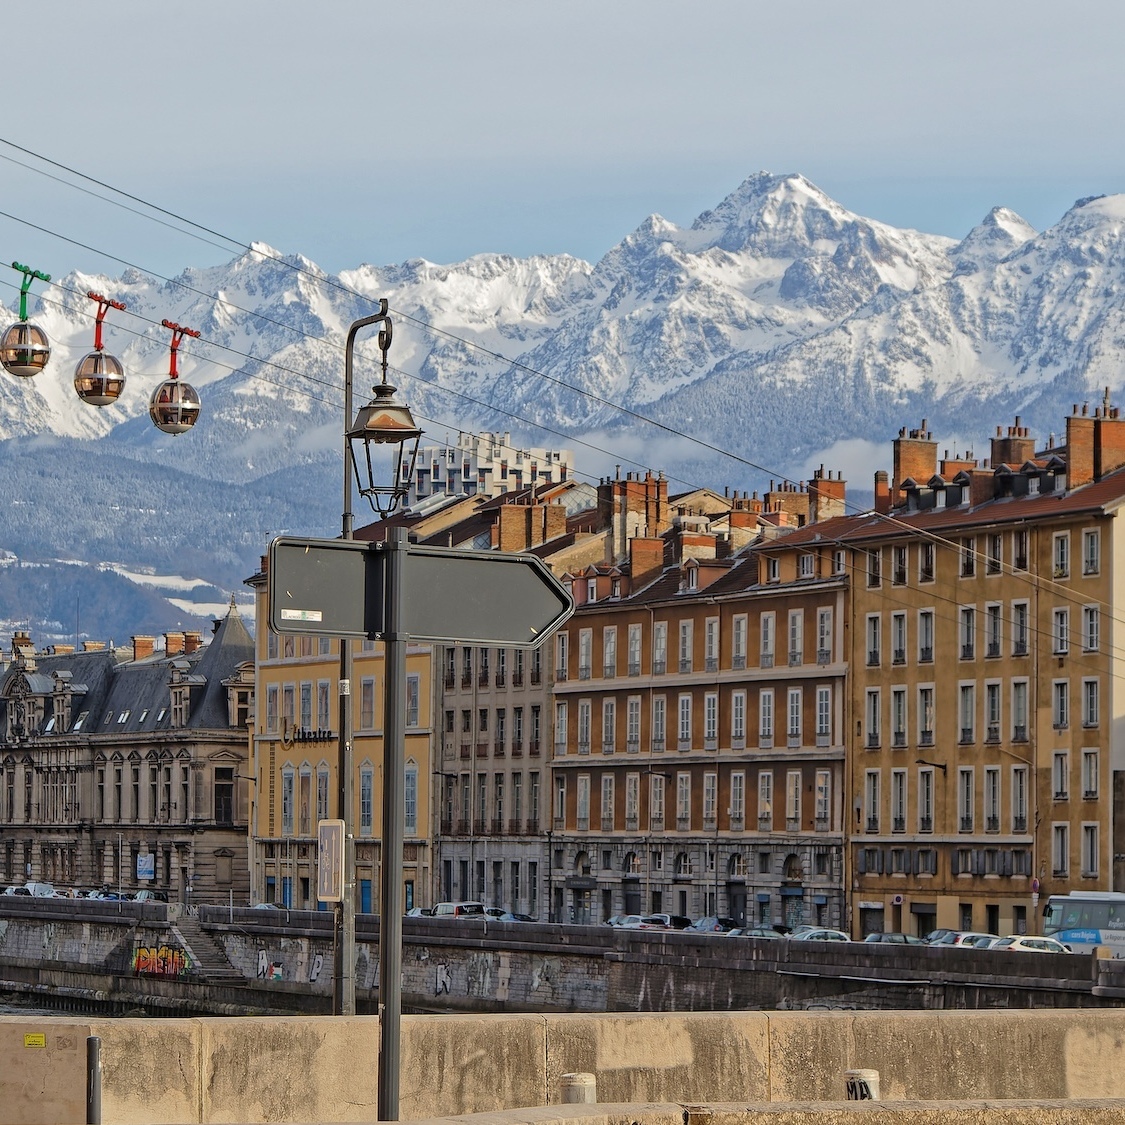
[[402, 547, 574, 645]]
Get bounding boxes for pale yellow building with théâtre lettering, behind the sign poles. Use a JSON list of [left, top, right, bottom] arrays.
[[249, 558, 434, 914]]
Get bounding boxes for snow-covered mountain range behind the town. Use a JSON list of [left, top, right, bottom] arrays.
[[0, 172, 1125, 636]]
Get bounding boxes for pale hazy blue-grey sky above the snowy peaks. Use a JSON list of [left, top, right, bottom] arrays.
[[0, 0, 1125, 280]]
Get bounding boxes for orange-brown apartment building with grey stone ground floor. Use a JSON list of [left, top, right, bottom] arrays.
[[550, 474, 847, 926]]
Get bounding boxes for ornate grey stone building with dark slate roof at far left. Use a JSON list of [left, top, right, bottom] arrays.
[[0, 601, 254, 903]]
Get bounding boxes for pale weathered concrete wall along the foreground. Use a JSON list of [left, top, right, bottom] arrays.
[[0, 1010, 1125, 1125]]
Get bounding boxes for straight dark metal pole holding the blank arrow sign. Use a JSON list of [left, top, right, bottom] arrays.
[[378, 528, 408, 1122]]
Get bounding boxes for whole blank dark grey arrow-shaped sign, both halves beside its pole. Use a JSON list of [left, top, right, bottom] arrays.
[[267, 537, 574, 646]]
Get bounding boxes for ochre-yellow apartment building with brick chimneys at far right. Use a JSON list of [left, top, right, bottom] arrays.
[[828, 403, 1125, 934]]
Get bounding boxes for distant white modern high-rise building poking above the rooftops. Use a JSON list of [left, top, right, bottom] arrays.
[[408, 432, 574, 505]]
